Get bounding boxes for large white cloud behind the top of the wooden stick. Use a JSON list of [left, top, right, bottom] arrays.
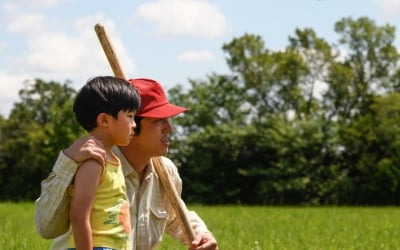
[[8, 14, 135, 84]]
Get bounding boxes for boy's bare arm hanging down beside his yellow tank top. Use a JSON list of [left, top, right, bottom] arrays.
[[70, 160, 102, 249]]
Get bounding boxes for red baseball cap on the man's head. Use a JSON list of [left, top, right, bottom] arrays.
[[129, 78, 188, 118]]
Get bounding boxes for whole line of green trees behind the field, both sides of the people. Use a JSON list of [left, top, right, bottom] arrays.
[[0, 17, 400, 205]]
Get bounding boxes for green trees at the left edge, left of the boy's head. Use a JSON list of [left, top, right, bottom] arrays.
[[0, 79, 82, 200]]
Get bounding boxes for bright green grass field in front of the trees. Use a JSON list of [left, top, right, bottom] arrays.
[[0, 203, 400, 250]]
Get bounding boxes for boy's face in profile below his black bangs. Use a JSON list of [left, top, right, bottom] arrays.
[[112, 110, 136, 146]]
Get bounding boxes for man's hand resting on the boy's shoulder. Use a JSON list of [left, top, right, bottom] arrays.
[[64, 136, 106, 166]]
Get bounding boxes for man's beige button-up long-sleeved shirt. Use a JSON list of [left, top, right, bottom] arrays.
[[35, 147, 208, 250]]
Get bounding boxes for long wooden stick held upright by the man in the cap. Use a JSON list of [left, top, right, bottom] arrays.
[[94, 24, 195, 246]]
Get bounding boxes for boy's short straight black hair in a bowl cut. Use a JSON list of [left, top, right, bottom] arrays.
[[73, 76, 140, 131]]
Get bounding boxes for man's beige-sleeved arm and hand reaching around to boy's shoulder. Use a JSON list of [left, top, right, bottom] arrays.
[[35, 137, 105, 239]]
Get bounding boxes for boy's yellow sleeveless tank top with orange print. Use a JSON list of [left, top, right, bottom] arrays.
[[69, 161, 131, 250]]
